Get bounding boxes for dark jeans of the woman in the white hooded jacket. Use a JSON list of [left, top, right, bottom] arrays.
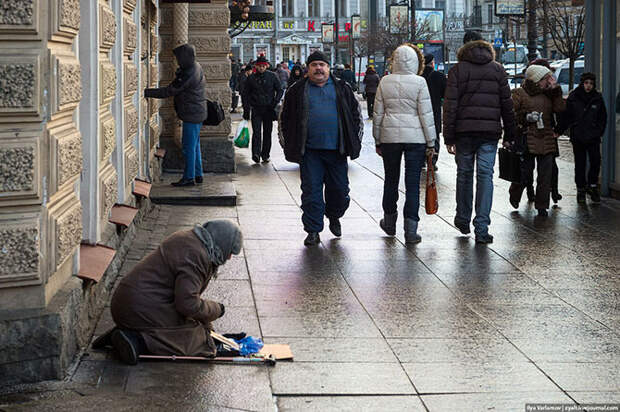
[[381, 143, 426, 222]]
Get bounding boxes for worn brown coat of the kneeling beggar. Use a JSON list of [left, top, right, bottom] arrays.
[[111, 230, 222, 356]]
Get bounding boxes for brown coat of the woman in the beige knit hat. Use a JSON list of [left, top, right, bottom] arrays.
[[512, 79, 566, 155]]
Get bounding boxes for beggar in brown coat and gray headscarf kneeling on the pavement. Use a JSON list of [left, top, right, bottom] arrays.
[[104, 220, 243, 365]]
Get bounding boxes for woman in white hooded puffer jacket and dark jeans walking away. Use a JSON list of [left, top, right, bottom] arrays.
[[372, 44, 435, 243]]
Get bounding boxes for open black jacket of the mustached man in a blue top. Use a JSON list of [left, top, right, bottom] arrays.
[[278, 76, 364, 163]]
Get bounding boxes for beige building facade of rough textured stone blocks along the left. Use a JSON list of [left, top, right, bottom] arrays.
[[0, 0, 232, 385]]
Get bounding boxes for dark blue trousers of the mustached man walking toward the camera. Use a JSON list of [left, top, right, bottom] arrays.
[[299, 149, 351, 233]]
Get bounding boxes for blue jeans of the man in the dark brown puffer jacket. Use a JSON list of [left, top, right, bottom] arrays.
[[454, 138, 497, 236]]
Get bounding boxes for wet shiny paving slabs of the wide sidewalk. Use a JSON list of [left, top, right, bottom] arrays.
[[0, 110, 620, 411]]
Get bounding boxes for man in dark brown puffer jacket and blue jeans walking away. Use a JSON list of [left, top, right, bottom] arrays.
[[443, 31, 515, 243]]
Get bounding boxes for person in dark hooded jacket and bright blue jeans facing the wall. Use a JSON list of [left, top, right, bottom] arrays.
[[144, 44, 207, 186]]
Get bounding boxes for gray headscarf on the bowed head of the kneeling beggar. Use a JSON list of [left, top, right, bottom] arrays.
[[194, 220, 243, 266]]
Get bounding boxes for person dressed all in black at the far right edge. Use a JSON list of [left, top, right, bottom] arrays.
[[556, 73, 607, 203]]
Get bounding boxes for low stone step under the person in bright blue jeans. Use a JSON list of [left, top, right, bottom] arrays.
[[150, 174, 237, 206]]
